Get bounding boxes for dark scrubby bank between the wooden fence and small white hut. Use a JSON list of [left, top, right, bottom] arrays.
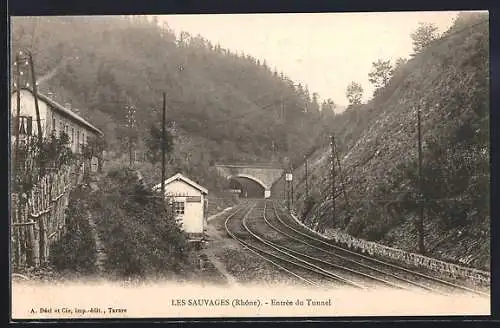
[[50, 170, 198, 279]]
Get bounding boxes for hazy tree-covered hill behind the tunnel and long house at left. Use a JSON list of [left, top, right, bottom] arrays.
[[12, 16, 333, 187]]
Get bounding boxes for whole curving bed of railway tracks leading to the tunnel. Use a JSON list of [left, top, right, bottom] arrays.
[[225, 200, 489, 296]]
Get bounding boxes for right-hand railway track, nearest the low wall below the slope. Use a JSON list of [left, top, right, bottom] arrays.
[[264, 202, 489, 297]]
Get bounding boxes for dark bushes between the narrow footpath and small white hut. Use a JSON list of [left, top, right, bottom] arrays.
[[91, 169, 191, 277]]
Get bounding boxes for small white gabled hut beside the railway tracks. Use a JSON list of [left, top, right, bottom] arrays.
[[154, 173, 208, 239]]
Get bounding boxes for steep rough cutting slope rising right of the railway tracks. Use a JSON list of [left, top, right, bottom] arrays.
[[295, 14, 490, 269]]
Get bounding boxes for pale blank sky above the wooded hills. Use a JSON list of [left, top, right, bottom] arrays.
[[158, 11, 458, 106]]
